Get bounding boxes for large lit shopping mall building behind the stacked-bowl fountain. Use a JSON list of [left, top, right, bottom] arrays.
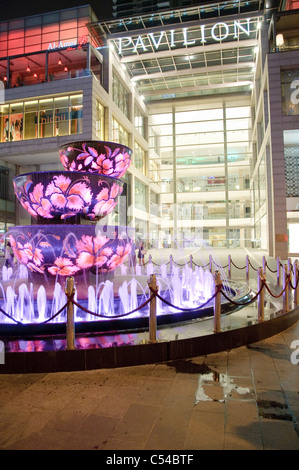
[[0, 0, 299, 259]]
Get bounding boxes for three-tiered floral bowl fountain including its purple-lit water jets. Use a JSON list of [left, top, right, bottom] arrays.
[[0, 141, 246, 331]]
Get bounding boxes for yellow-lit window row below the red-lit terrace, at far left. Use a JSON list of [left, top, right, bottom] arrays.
[[0, 94, 83, 142]]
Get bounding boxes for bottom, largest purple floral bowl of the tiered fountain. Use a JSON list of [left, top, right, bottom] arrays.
[[9, 225, 131, 276]]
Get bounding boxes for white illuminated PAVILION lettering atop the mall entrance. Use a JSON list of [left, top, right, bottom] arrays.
[[115, 18, 251, 54]]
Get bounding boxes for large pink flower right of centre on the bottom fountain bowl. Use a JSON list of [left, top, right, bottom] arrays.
[[76, 235, 112, 269]]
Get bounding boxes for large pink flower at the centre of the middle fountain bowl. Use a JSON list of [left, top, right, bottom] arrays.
[[46, 175, 92, 219]]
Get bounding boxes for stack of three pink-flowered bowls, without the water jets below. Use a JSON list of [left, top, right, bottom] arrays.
[[8, 141, 132, 277]]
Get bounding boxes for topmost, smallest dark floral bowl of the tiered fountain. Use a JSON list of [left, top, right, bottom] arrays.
[[59, 141, 132, 178]]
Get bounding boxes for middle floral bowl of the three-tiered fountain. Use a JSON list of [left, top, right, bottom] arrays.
[[13, 171, 124, 220]]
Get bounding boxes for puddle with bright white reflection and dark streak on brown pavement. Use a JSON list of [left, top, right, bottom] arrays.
[[168, 360, 252, 405]]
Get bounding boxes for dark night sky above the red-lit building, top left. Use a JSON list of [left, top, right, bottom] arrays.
[[0, 0, 112, 21]]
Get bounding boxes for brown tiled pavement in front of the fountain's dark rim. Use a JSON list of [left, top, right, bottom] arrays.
[[0, 248, 299, 454]]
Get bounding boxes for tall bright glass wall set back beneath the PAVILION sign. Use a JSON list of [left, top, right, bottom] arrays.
[[149, 103, 251, 246]]
